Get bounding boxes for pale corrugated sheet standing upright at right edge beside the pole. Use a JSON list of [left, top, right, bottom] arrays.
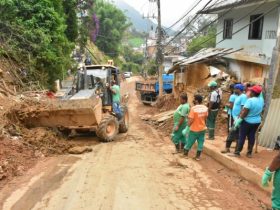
[[259, 99, 280, 149]]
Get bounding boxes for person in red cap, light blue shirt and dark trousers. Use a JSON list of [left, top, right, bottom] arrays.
[[234, 85, 264, 158]]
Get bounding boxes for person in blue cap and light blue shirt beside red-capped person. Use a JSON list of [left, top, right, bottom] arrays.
[[222, 84, 247, 153]]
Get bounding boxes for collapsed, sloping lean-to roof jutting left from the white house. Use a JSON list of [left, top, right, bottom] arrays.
[[168, 48, 239, 74]]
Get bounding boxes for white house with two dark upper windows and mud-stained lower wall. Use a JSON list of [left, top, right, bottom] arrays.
[[200, 0, 280, 82]]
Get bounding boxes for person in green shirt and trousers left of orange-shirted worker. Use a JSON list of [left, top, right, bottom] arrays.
[[171, 93, 190, 153]]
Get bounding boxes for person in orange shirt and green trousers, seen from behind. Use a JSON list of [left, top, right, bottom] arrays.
[[184, 95, 208, 160]]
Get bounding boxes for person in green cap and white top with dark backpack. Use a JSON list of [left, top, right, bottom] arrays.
[[207, 81, 222, 140]]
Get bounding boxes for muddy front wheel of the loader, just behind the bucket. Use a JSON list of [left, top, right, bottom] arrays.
[[96, 115, 119, 142]]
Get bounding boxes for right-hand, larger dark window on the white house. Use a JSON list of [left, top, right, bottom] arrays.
[[249, 14, 264, 39]]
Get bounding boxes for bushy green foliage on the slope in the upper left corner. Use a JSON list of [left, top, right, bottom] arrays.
[[0, 0, 74, 85]]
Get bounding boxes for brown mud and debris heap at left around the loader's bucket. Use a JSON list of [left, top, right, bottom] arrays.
[[0, 92, 92, 188]]
